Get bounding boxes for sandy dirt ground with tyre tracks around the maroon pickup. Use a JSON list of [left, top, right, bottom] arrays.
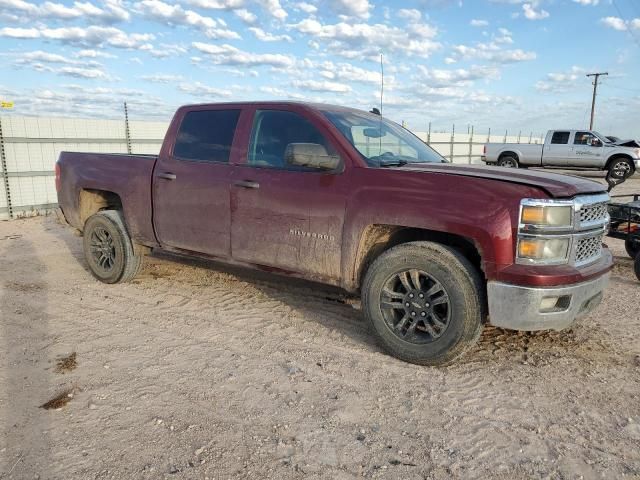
[[0, 174, 640, 480]]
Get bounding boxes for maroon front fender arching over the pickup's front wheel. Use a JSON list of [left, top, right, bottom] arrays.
[[342, 169, 546, 290]]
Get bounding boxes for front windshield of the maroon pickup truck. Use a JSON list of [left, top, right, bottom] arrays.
[[324, 111, 447, 167]]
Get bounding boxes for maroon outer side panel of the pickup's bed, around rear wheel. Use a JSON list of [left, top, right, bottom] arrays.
[[58, 152, 158, 244]]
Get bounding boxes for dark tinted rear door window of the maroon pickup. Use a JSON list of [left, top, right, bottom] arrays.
[[173, 110, 240, 163]]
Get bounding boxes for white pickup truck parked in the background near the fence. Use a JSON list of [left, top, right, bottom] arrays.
[[482, 130, 640, 178]]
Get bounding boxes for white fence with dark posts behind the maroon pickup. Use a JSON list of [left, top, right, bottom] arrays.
[[0, 116, 540, 219]]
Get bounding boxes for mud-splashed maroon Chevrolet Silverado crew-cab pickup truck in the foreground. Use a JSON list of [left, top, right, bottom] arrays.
[[56, 102, 612, 365]]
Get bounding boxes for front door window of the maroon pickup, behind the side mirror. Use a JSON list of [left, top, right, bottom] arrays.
[[248, 110, 336, 171]]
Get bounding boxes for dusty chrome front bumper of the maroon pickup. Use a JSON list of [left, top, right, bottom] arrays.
[[487, 273, 609, 331]]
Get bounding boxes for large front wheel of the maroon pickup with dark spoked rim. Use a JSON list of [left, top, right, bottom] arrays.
[[362, 242, 484, 365]]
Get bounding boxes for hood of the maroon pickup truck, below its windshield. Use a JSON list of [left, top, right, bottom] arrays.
[[402, 163, 607, 198]]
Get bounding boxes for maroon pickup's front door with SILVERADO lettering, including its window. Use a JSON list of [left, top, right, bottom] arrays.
[[231, 108, 348, 283]]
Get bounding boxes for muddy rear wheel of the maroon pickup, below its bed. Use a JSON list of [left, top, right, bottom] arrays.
[[83, 210, 142, 283]]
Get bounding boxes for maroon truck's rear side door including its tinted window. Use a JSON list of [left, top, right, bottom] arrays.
[[153, 107, 241, 257]]
